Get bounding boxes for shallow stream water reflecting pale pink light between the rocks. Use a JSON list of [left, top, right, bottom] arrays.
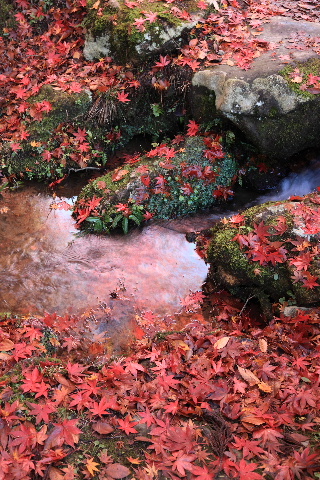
[[0, 163, 320, 323]]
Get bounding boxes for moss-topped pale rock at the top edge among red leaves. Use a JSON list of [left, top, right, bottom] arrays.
[[83, 0, 198, 62]]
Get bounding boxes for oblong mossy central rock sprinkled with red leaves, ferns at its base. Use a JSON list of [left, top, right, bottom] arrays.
[[76, 137, 237, 230]]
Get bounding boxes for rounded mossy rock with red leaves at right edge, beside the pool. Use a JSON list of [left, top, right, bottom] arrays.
[[207, 194, 320, 306]]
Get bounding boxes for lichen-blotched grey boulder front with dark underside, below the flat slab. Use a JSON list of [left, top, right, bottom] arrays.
[[191, 54, 320, 158]]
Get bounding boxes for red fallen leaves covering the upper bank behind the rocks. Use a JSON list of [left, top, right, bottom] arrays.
[[0, 0, 318, 176]]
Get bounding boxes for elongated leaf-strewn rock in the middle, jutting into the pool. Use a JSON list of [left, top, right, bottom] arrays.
[[75, 136, 237, 232]]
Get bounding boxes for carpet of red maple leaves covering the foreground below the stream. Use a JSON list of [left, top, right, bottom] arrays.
[[0, 298, 320, 480]]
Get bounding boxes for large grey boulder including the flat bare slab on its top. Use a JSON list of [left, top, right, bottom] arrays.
[[192, 17, 320, 158]]
